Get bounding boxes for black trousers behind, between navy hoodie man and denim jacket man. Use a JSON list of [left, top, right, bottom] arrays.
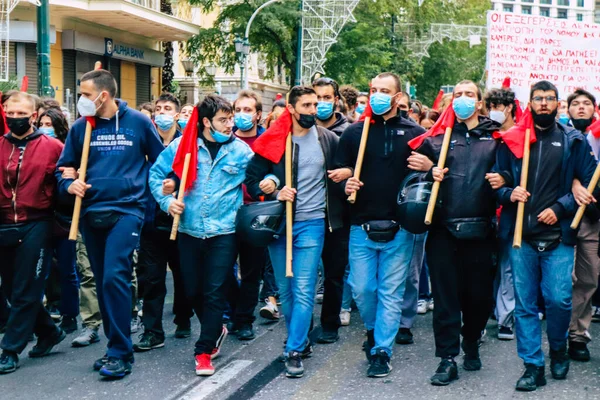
[[137, 228, 194, 340]]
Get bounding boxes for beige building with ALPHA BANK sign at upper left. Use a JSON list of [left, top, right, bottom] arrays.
[[9, 0, 199, 115]]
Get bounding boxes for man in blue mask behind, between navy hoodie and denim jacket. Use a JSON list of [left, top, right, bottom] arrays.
[[133, 93, 194, 352]]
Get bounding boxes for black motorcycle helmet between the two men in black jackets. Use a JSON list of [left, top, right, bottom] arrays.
[[398, 172, 441, 234]]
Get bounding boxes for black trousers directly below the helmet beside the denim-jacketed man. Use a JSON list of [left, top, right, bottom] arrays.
[[229, 238, 268, 327]]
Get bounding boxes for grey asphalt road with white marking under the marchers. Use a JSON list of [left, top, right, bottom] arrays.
[[0, 272, 600, 400]]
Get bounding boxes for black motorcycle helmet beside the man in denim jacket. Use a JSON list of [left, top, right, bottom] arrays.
[[235, 200, 285, 247]]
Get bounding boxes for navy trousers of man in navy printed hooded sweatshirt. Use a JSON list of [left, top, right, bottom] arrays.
[[81, 215, 144, 359]]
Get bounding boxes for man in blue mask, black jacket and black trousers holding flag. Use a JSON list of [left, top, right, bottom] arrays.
[[417, 81, 500, 386]]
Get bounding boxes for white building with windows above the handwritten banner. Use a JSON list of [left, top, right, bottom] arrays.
[[492, 0, 600, 22]]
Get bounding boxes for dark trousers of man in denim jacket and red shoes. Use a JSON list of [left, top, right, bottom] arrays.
[[179, 233, 237, 354]]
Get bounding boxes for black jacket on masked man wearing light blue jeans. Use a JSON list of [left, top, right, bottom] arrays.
[[336, 115, 425, 225]]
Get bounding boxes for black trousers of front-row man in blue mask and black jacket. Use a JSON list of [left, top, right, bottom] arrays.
[[425, 228, 496, 358]]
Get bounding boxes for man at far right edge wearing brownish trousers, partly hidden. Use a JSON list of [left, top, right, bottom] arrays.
[[567, 89, 600, 361]]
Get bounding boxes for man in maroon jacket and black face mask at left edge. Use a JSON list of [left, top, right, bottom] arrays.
[[0, 92, 66, 374]]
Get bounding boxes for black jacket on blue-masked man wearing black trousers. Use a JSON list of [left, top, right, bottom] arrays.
[[417, 116, 500, 224]]
